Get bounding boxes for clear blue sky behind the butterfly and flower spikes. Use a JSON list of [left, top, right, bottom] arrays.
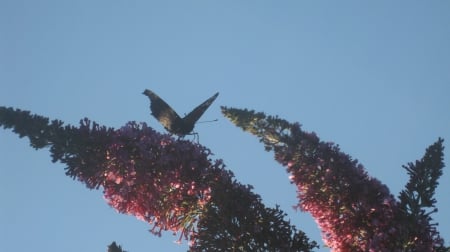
[[0, 0, 450, 252]]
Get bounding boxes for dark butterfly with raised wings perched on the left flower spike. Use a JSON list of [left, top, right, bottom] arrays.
[[143, 89, 219, 136]]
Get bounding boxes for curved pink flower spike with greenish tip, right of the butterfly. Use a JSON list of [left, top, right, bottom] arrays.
[[222, 107, 442, 252]]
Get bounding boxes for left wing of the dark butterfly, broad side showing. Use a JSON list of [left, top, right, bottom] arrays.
[[143, 89, 183, 135]]
